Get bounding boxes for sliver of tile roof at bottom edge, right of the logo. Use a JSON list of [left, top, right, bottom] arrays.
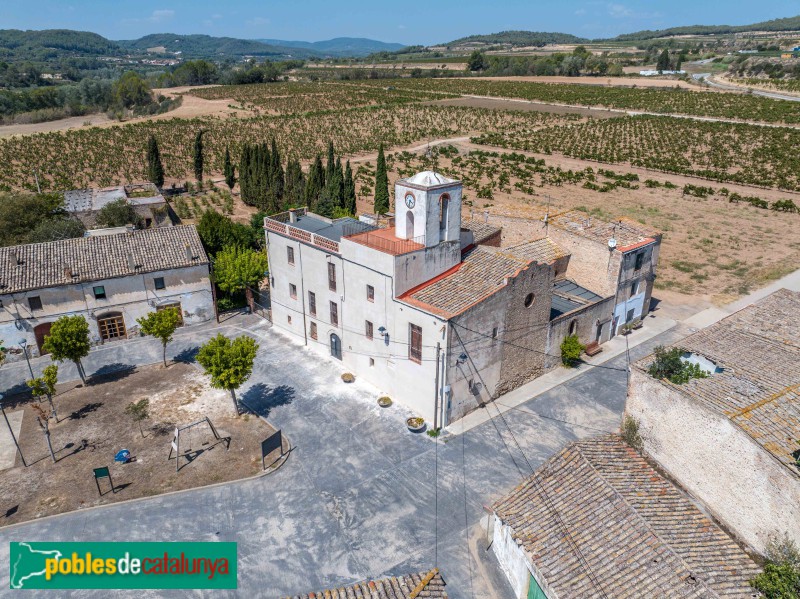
[[286, 569, 447, 599]]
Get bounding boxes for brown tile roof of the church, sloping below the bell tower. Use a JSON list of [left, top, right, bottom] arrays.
[[399, 246, 530, 318]]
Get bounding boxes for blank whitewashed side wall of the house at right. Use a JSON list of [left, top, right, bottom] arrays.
[[626, 368, 800, 552]]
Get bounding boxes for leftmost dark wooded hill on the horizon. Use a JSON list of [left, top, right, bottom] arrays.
[[0, 29, 121, 61]]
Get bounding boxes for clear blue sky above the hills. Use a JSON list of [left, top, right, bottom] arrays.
[[0, 0, 800, 45]]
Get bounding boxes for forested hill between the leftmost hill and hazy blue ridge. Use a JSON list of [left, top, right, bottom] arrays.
[[117, 33, 313, 58]]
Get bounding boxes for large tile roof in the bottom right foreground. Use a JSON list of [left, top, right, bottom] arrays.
[[494, 435, 759, 599]]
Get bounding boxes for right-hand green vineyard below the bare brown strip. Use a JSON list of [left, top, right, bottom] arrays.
[[473, 116, 800, 190]]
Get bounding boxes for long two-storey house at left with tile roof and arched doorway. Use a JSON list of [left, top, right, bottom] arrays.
[[0, 225, 214, 360]]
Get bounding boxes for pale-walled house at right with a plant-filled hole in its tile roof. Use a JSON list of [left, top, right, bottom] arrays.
[[626, 289, 800, 552]]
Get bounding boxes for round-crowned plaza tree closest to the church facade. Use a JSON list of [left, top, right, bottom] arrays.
[[197, 333, 258, 416]]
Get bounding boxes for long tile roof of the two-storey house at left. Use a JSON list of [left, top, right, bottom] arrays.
[[0, 225, 208, 294]]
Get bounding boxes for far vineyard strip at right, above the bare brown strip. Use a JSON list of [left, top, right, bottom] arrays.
[[348, 78, 800, 124]]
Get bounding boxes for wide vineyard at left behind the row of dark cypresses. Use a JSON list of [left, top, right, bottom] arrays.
[[0, 105, 577, 190]]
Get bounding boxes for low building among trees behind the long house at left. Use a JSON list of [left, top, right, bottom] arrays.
[[64, 183, 172, 229]]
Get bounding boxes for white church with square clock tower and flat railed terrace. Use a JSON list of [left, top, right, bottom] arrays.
[[264, 171, 660, 428]]
